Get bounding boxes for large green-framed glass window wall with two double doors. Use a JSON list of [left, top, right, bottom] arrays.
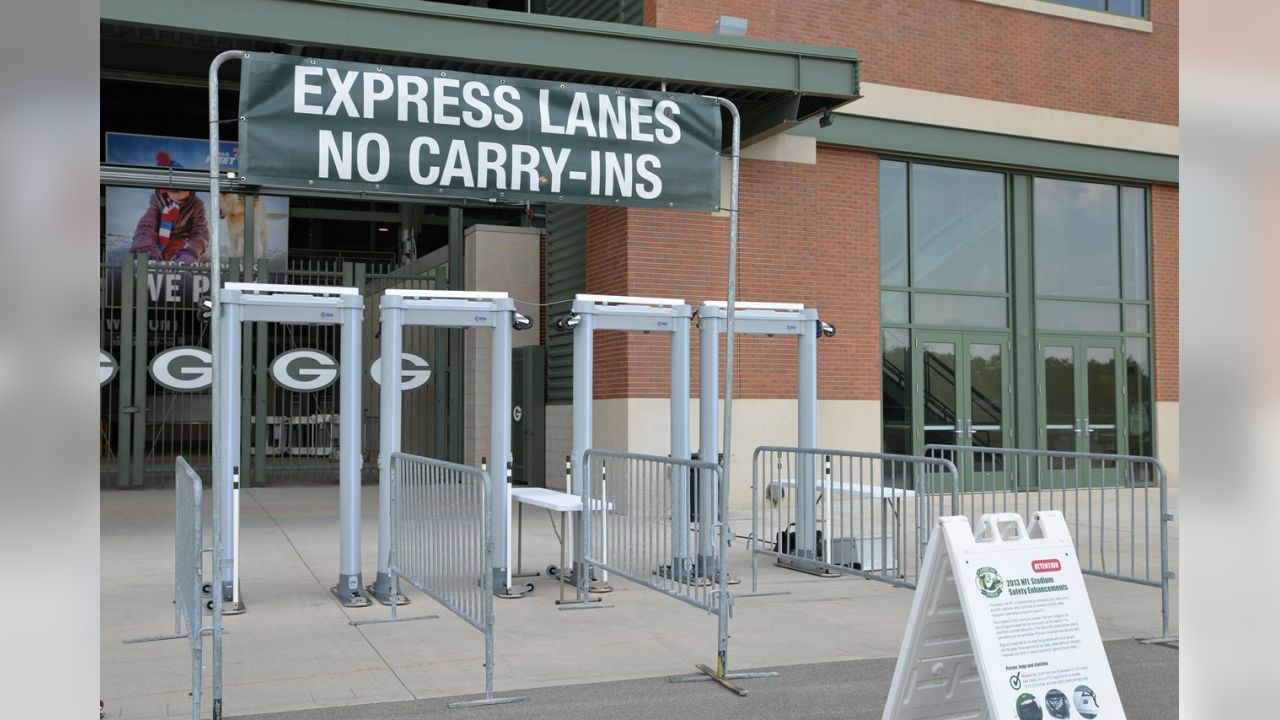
[[878, 159, 1155, 455]]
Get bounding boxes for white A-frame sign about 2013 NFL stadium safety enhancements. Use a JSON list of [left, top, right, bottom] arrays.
[[883, 510, 1125, 720]]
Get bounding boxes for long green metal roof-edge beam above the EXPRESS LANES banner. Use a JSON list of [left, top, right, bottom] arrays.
[[101, 0, 859, 100]]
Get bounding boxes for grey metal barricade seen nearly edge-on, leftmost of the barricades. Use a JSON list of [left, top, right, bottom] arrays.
[[173, 455, 221, 720]]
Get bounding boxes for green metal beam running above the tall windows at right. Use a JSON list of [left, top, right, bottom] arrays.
[[792, 114, 1178, 184]]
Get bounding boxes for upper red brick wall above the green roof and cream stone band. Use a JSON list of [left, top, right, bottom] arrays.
[[645, 0, 1178, 124]]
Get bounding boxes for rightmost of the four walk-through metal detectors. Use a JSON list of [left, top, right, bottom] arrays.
[[696, 301, 836, 574]]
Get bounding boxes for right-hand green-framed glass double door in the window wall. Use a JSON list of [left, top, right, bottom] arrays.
[[1038, 337, 1126, 484]]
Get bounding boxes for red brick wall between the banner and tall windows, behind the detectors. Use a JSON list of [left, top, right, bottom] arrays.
[[588, 147, 881, 400]]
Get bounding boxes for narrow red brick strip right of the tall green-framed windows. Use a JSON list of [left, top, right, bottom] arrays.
[[1151, 184, 1178, 402]]
